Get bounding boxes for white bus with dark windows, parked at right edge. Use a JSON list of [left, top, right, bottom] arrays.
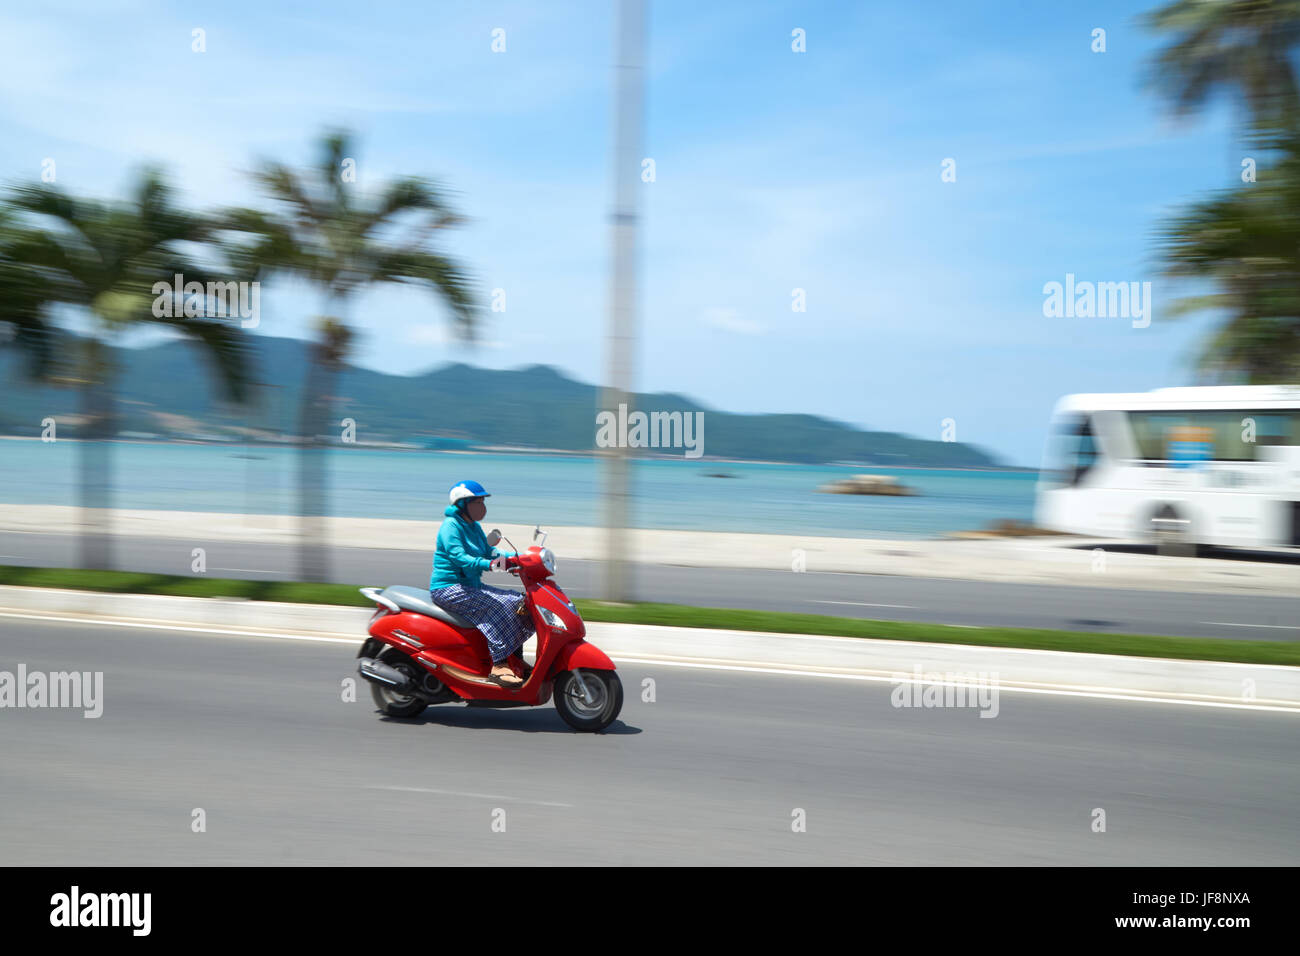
[[1035, 385, 1300, 551]]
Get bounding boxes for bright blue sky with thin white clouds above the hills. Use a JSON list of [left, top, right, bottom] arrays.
[[0, 0, 1251, 467]]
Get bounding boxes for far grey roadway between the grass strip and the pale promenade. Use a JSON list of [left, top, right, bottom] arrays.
[[0, 532, 1300, 641]]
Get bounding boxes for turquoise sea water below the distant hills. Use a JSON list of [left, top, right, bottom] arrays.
[[0, 438, 1037, 538]]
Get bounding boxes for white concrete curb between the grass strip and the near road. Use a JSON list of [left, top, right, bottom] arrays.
[[0, 587, 1300, 713]]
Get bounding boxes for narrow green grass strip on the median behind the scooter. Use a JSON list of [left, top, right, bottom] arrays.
[[0, 564, 1300, 666]]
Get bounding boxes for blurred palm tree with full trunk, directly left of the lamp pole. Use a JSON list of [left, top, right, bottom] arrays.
[[230, 131, 477, 580]]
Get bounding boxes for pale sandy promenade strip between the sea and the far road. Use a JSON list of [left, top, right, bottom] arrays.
[[0, 505, 1300, 597]]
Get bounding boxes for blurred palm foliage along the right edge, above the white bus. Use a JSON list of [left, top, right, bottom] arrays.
[[1144, 0, 1300, 382]]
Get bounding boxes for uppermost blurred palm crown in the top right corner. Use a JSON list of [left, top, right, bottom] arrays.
[[1143, 0, 1300, 130]]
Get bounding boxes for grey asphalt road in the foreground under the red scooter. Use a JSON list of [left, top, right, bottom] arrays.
[[0, 618, 1300, 866]]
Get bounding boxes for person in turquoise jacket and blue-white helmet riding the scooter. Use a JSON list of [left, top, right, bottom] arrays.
[[429, 481, 534, 687]]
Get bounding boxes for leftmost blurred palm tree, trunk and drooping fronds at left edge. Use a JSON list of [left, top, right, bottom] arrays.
[[5, 169, 247, 568]]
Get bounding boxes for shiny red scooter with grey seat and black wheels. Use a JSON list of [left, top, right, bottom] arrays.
[[358, 531, 623, 732]]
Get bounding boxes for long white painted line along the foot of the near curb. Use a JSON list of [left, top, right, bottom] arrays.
[[0, 611, 1300, 714]]
